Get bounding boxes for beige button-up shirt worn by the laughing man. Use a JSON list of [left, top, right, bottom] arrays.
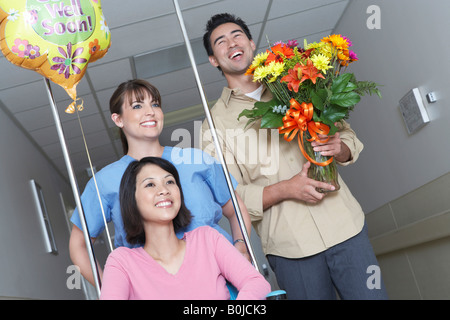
[[200, 88, 364, 258]]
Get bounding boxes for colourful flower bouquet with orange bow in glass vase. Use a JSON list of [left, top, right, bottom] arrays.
[[239, 35, 381, 192]]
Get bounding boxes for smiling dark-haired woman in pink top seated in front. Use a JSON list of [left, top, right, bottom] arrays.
[[100, 157, 270, 300]]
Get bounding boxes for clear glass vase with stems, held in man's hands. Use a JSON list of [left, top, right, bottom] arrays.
[[303, 131, 341, 193]]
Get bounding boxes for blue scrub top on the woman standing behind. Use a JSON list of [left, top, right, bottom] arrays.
[[71, 147, 237, 248]]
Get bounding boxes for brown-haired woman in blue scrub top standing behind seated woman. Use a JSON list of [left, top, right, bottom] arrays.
[[69, 79, 251, 284]]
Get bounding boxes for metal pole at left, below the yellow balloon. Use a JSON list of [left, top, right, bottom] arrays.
[[44, 78, 100, 297]]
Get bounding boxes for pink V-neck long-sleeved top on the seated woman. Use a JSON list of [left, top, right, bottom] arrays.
[[100, 226, 270, 300]]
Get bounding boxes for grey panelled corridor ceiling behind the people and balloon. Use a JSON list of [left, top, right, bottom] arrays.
[[0, 0, 349, 187]]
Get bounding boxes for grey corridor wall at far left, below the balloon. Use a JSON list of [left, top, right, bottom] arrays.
[[0, 103, 85, 299]]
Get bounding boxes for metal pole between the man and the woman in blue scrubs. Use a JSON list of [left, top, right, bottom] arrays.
[[173, 0, 259, 271]]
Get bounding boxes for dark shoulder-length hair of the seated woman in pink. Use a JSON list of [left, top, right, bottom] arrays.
[[119, 157, 192, 245]]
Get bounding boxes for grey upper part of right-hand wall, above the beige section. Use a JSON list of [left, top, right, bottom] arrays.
[[336, 0, 450, 213]]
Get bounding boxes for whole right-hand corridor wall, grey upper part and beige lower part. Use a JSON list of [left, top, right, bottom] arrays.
[[330, 0, 450, 299]]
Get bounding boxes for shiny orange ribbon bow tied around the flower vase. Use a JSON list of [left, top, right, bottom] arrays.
[[278, 99, 333, 167]]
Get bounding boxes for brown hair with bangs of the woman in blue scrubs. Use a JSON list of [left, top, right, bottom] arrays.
[[109, 79, 161, 154]]
